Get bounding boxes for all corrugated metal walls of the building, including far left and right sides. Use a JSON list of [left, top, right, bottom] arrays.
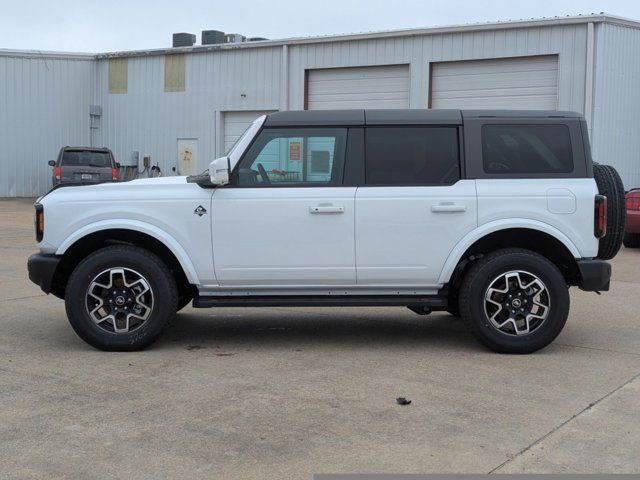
[[6, 23, 640, 196]]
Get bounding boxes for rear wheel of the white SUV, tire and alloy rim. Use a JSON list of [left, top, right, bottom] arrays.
[[460, 249, 569, 354]]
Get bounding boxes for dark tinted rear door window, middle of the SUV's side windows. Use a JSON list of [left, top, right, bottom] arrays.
[[365, 127, 460, 185]]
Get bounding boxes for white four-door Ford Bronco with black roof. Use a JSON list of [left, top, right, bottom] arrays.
[[28, 110, 624, 353]]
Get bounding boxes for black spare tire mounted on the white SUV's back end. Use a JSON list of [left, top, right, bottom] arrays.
[[593, 163, 627, 260]]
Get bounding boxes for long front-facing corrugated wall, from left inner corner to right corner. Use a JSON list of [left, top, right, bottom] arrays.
[[96, 24, 587, 180]]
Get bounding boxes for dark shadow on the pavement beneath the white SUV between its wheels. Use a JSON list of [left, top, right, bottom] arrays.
[[155, 310, 485, 350]]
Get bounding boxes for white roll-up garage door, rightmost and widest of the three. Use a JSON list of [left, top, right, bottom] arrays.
[[431, 55, 558, 110]]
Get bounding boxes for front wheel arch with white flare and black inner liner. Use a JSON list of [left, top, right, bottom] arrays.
[[52, 222, 198, 297]]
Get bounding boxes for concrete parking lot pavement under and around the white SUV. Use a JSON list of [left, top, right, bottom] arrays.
[[0, 200, 640, 479]]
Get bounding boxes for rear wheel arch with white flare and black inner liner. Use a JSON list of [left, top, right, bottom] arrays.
[[439, 221, 580, 284]]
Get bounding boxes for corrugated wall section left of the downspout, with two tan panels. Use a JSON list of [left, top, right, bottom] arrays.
[[96, 47, 282, 175]]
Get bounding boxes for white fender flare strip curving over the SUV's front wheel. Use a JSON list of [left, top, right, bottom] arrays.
[[55, 219, 199, 284]]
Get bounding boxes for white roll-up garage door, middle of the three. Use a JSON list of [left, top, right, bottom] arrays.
[[306, 65, 409, 110]]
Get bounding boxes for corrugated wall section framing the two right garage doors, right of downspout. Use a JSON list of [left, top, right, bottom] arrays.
[[289, 24, 587, 112]]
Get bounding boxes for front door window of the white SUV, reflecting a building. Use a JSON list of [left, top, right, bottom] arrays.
[[238, 128, 347, 185]]
